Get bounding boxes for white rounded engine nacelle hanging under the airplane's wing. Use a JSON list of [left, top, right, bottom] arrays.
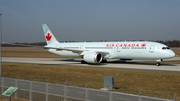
[[83, 52, 102, 63]]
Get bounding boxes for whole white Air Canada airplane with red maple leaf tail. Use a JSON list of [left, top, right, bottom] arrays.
[[42, 24, 175, 66]]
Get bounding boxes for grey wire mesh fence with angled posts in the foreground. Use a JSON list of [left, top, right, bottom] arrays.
[[0, 77, 175, 101]]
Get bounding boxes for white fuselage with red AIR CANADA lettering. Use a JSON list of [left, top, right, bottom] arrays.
[[47, 41, 175, 60]]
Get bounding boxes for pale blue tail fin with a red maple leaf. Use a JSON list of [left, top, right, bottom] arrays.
[[42, 24, 59, 45]]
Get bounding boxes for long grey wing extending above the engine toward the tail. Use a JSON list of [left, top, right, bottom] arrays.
[[43, 47, 109, 55]]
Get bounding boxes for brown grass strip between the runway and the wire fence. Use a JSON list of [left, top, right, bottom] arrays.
[[2, 63, 180, 100]]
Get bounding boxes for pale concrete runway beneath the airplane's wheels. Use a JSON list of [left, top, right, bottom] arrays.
[[2, 57, 180, 74]]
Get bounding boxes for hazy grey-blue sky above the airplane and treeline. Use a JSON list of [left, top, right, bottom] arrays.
[[0, 0, 180, 42]]
